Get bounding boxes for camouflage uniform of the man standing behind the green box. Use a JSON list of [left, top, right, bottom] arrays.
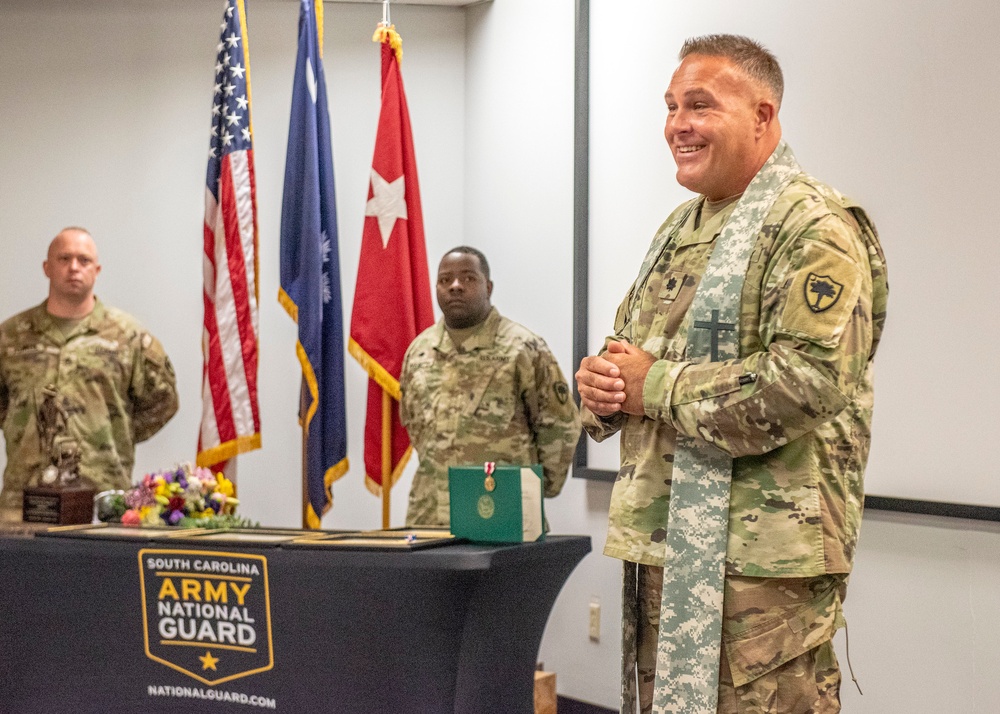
[[399, 308, 580, 525]]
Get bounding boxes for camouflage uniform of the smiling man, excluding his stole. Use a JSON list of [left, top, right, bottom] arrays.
[[583, 174, 888, 701]]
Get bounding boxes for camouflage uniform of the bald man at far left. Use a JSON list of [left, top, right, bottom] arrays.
[[0, 301, 177, 513]]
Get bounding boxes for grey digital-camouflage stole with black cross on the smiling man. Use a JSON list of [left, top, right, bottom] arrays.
[[640, 141, 800, 714]]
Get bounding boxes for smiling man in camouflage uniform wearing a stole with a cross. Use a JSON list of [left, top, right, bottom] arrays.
[[576, 35, 888, 714]]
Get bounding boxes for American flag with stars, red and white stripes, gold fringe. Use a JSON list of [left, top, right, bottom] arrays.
[[197, 0, 260, 466]]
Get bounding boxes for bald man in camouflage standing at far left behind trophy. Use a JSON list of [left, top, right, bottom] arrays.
[[0, 228, 177, 520]]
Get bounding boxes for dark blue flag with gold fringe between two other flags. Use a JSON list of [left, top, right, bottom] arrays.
[[278, 0, 348, 528]]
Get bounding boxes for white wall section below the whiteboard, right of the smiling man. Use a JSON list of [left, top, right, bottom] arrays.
[[836, 511, 1000, 714]]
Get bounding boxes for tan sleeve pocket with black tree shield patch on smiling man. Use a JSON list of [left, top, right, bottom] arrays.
[[777, 242, 862, 347]]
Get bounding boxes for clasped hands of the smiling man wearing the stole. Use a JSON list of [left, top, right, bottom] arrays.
[[576, 340, 656, 416]]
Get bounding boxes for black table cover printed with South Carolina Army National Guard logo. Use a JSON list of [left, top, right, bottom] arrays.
[[0, 524, 590, 714]]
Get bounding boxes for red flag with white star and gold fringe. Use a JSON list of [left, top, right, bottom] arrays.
[[348, 26, 434, 495]]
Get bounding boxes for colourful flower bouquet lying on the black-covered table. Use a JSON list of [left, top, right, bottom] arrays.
[[98, 463, 257, 528]]
